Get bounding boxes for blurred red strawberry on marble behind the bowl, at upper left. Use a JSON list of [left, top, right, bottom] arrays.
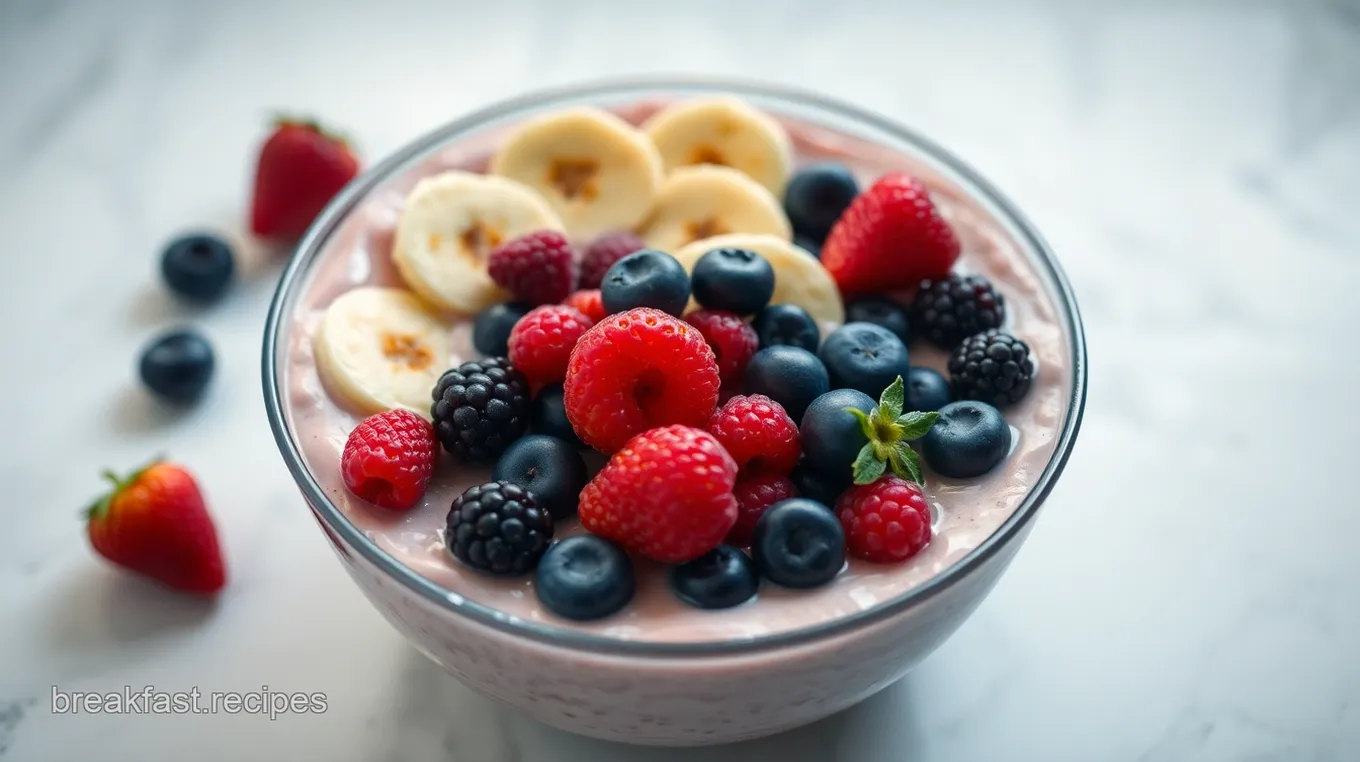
[[250, 118, 359, 239]]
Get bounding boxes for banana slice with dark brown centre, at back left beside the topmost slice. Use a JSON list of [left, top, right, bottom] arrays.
[[491, 107, 661, 238]]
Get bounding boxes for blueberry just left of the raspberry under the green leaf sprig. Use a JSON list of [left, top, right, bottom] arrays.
[[751, 498, 846, 588]]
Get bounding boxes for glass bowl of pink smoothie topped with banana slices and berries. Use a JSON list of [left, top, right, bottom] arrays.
[[264, 82, 1085, 746]]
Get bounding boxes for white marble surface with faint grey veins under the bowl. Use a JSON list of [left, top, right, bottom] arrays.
[[0, 0, 1360, 762]]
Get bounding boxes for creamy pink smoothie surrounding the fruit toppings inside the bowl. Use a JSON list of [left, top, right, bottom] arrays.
[[283, 97, 1072, 642]]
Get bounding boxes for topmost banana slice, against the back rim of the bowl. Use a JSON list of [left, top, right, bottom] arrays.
[[642, 97, 793, 196]]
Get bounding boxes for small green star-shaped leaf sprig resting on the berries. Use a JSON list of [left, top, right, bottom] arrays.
[[845, 376, 940, 486]]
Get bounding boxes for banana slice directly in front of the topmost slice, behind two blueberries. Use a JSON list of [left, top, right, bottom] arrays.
[[639, 165, 793, 253]]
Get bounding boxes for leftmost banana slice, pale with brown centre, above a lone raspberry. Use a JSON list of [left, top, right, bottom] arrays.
[[311, 286, 450, 419]]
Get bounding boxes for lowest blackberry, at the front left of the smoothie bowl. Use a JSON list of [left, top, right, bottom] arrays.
[[443, 482, 552, 574]]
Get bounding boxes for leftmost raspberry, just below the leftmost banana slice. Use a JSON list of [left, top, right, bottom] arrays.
[[340, 410, 438, 510]]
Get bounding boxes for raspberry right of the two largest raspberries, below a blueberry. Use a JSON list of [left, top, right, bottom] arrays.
[[709, 395, 802, 476]]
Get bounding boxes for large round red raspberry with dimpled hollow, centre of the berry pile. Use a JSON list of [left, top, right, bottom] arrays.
[[563, 308, 719, 453]]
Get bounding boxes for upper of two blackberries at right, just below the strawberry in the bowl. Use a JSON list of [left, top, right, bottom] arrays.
[[911, 275, 1006, 350]]
